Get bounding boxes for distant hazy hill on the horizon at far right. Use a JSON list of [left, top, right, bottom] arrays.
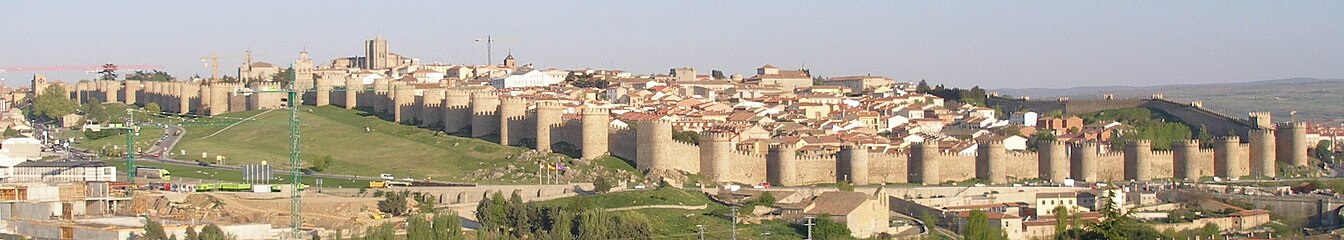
[[995, 78, 1344, 121]]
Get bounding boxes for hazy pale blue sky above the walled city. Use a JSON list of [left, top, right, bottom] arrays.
[[0, 1, 1344, 87]]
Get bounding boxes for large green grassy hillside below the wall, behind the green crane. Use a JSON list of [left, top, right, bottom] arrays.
[[165, 106, 634, 184]]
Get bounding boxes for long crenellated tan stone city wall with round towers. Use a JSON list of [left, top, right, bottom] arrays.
[[55, 78, 1308, 186]]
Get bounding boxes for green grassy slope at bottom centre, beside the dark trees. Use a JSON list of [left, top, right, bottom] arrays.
[[540, 188, 802, 239]]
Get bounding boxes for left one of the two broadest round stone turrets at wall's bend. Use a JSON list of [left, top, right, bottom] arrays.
[[634, 119, 675, 172]]
